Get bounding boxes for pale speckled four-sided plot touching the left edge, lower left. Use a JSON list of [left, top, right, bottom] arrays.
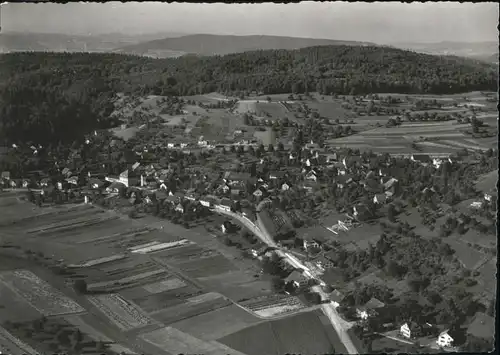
[[0, 270, 85, 316]]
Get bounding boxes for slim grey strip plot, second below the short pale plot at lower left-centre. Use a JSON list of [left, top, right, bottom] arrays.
[[151, 297, 231, 325]]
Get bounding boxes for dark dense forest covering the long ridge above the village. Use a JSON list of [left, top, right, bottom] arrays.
[[0, 46, 498, 143]]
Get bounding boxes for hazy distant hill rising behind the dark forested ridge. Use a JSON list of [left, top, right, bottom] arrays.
[[116, 34, 374, 58]]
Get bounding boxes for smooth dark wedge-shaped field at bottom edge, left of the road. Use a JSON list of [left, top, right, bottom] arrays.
[[219, 312, 340, 355]]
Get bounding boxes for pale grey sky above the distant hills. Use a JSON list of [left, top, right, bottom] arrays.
[[1, 2, 499, 44]]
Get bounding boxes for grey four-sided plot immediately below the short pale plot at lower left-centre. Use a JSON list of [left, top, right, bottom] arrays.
[[133, 285, 202, 313]]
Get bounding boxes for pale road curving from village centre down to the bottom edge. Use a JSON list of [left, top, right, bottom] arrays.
[[213, 208, 359, 354]]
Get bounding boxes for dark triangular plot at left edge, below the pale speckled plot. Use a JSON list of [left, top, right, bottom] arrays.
[[0, 282, 41, 322]]
